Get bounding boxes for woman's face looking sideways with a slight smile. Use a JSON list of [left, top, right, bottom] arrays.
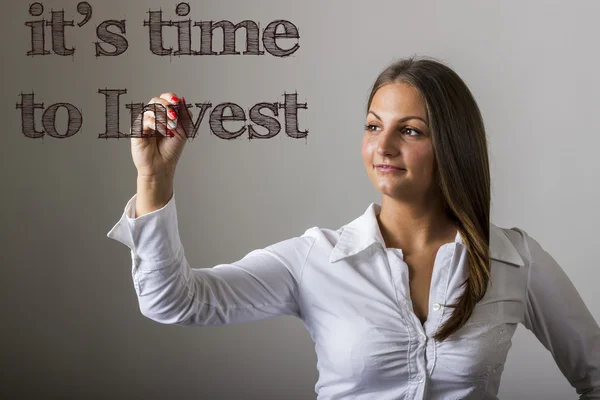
[[362, 83, 435, 203]]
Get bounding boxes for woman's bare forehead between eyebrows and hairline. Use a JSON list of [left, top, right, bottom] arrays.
[[369, 83, 427, 120]]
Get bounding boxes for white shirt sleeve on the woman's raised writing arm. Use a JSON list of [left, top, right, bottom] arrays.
[[107, 194, 315, 325]]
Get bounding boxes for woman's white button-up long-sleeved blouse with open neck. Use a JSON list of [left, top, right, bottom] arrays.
[[107, 195, 600, 400]]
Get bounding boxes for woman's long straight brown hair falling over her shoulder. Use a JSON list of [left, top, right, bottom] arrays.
[[367, 56, 490, 341]]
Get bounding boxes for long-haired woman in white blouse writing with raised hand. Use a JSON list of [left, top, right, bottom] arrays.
[[108, 58, 600, 400]]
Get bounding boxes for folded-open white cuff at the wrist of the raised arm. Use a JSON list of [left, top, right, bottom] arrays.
[[106, 193, 183, 267]]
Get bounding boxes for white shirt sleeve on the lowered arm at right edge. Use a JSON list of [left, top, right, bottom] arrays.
[[524, 230, 600, 400]]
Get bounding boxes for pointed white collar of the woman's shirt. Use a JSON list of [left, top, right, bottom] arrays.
[[329, 203, 525, 266]]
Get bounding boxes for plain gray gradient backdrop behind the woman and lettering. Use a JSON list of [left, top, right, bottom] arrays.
[[0, 0, 600, 399]]
